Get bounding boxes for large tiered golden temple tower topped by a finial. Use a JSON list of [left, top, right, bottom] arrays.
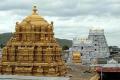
[[0, 6, 66, 76]]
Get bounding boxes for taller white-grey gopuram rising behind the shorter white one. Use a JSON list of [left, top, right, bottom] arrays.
[[88, 29, 110, 58]]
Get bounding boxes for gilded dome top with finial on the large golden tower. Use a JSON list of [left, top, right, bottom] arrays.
[[21, 6, 49, 26]]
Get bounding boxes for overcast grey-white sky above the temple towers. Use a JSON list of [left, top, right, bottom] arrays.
[[0, 0, 120, 46]]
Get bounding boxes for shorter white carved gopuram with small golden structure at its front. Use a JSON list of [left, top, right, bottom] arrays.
[[68, 38, 96, 64]]
